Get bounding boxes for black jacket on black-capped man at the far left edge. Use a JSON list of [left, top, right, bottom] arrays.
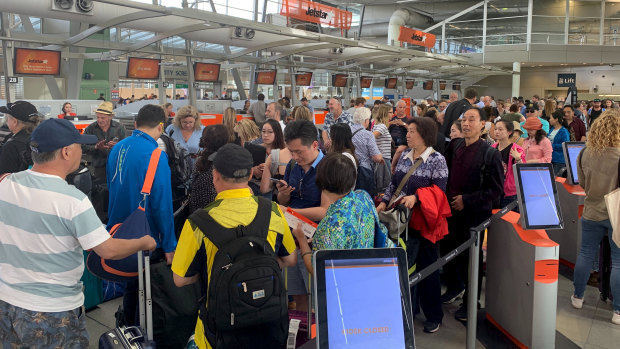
[[0, 130, 32, 174]]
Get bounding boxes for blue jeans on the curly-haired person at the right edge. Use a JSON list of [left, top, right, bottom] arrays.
[[573, 218, 620, 311]]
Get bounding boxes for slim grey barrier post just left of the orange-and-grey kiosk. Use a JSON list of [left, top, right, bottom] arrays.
[[466, 229, 480, 349]]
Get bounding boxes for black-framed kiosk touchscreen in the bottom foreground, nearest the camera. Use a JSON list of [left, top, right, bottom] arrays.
[[313, 248, 415, 349]]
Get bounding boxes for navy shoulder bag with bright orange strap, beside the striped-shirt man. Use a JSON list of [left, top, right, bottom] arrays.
[[86, 148, 162, 282]]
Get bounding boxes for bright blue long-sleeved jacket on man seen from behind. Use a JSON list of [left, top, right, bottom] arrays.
[[107, 130, 177, 252]]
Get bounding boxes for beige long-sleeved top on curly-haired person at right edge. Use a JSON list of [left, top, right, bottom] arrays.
[[577, 147, 620, 222]]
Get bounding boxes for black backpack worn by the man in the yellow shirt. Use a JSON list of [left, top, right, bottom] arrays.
[[189, 197, 288, 349]]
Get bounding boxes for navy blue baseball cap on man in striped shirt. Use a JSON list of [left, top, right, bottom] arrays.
[[30, 119, 98, 153]]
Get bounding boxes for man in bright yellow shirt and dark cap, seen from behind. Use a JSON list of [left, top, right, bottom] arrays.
[[172, 144, 297, 349]]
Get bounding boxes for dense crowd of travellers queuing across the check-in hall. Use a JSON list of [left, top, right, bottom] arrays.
[[0, 88, 620, 348]]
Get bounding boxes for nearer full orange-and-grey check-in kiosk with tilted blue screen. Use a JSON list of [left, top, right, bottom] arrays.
[[485, 164, 562, 349]]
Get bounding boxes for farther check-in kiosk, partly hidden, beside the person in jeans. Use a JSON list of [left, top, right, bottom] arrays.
[[547, 142, 586, 268]]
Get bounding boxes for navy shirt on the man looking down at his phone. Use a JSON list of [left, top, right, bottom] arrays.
[[284, 151, 323, 208]]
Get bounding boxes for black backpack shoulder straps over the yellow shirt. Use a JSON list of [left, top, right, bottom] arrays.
[[189, 196, 272, 250]]
